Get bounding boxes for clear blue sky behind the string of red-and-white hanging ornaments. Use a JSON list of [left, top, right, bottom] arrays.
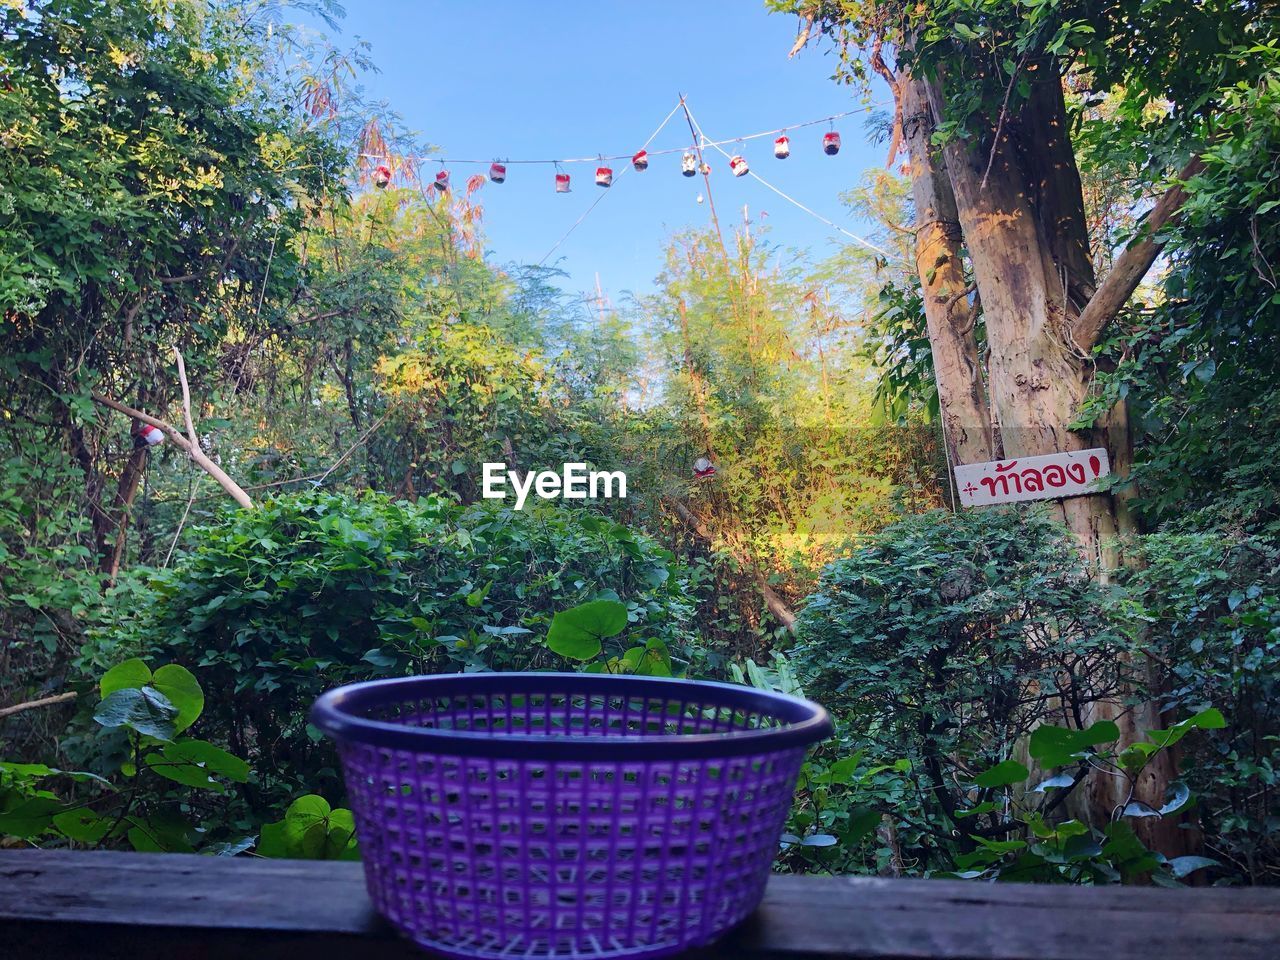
[[293, 0, 884, 303]]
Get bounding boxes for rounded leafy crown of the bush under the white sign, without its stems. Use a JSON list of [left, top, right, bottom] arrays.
[[792, 509, 1123, 745]]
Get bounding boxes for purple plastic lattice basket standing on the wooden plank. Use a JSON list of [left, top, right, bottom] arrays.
[[311, 673, 831, 960]]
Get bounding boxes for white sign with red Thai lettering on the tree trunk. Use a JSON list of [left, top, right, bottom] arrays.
[[955, 447, 1111, 507]]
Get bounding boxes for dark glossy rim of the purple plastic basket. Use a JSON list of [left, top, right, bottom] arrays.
[[311, 673, 833, 762]]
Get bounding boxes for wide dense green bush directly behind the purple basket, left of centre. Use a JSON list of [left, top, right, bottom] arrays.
[[84, 493, 696, 810]]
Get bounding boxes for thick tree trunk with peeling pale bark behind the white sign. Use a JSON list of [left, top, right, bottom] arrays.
[[913, 61, 1190, 856]]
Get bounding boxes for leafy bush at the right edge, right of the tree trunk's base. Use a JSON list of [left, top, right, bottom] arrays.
[[1130, 531, 1280, 883]]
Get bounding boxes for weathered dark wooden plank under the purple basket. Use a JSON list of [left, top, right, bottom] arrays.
[[0, 850, 1280, 960]]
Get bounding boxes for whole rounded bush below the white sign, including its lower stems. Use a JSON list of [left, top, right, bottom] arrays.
[[792, 509, 1128, 869]]
